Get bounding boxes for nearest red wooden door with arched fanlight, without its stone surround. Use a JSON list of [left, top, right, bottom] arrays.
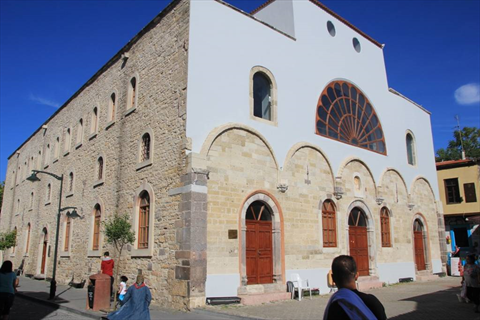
[[245, 201, 273, 285]]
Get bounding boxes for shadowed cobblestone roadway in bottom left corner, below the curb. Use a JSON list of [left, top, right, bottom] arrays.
[[8, 295, 91, 320]]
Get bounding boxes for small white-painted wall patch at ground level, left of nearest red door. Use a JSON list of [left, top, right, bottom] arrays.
[[205, 273, 240, 298]]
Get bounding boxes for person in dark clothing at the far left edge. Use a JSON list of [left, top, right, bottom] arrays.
[[0, 260, 19, 320]]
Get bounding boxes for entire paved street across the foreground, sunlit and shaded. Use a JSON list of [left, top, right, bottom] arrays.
[[14, 277, 480, 320]]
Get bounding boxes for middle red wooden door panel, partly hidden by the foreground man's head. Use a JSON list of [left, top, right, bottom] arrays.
[[348, 226, 370, 276]]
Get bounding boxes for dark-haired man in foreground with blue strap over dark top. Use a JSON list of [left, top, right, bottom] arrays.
[[323, 255, 387, 320]]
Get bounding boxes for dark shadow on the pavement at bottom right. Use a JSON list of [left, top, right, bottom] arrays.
[[389, 287, 480, 320]]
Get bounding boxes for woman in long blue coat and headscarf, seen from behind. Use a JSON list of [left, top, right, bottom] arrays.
[[107, 275, 152, 320]]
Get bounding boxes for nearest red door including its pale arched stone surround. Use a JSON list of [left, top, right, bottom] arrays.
[[240, 191, 285, 286]]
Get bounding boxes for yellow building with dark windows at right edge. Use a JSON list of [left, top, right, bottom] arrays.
[[437, 159, 480, 256]]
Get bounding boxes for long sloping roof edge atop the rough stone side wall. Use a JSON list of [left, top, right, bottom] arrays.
[[7, 0, 182, 160]]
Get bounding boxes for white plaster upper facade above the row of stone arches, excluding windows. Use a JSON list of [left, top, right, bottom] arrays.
[[187, 0, 438, 198]]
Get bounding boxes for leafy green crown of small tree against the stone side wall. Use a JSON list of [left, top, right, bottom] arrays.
[[103, 214, 135, 251]]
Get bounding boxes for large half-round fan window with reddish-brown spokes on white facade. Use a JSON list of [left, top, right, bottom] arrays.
[[316, 81, 387, 154]]
